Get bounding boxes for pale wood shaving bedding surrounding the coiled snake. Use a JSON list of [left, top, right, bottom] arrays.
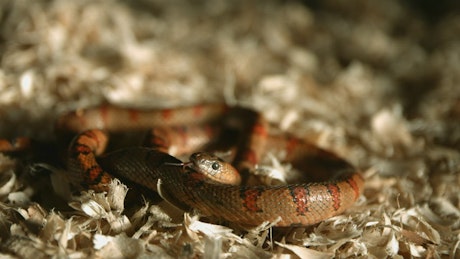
[[0, 0, 460, 258]]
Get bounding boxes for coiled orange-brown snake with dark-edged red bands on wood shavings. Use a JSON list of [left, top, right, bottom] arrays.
[[0, 104, 364, 227]]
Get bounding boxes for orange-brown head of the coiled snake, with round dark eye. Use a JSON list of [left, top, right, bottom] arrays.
[[187, 152, 241, 185]]
